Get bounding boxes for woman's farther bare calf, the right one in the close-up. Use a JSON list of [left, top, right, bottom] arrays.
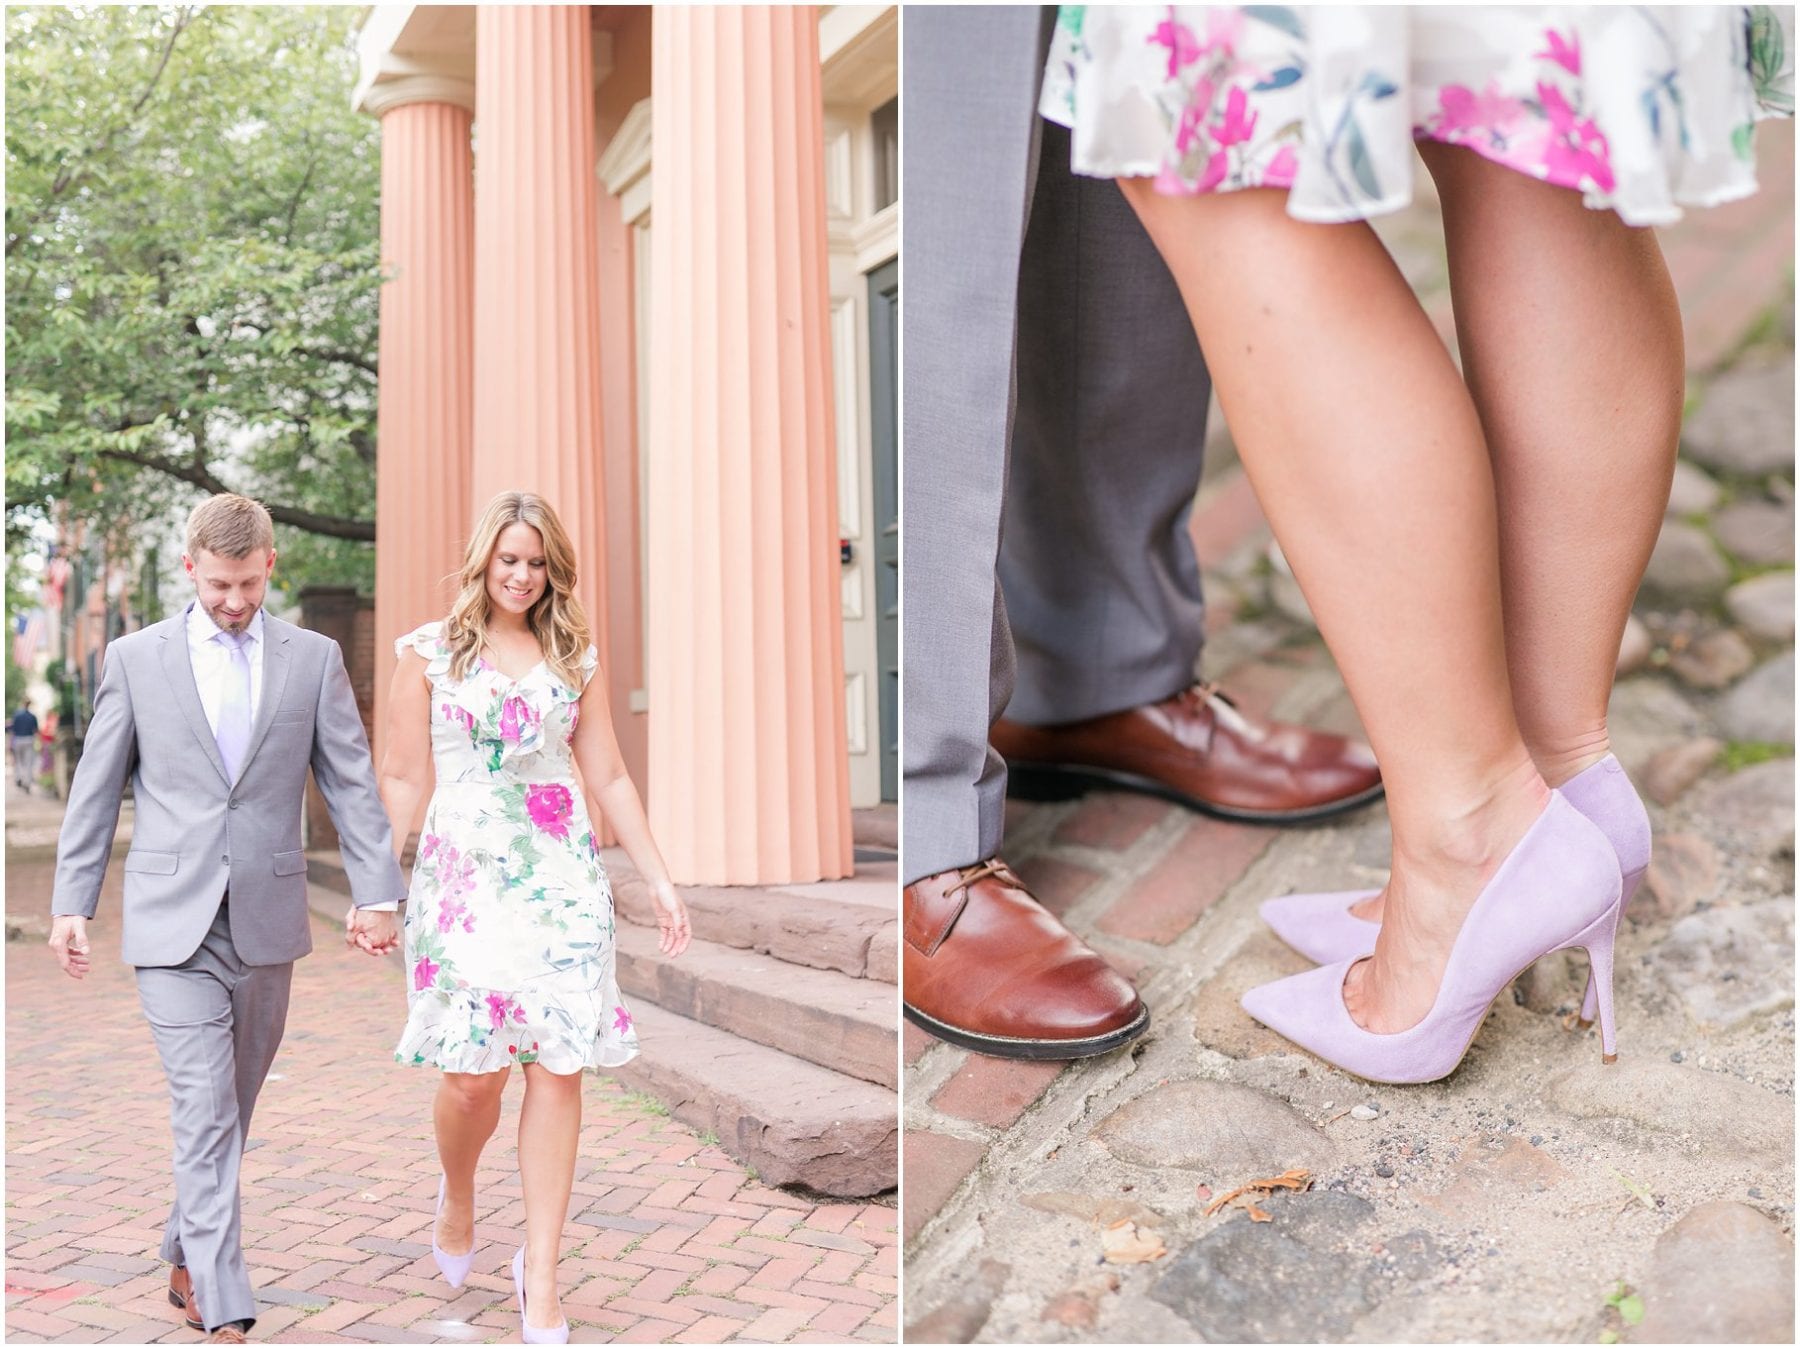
[[1420, 142, 1685, 785]]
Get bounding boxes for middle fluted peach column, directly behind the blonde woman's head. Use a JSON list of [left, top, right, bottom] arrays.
[[473, 5, 610, 668]]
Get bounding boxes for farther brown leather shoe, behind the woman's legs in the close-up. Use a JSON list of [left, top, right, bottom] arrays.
[[988, 683, 1381, 825]]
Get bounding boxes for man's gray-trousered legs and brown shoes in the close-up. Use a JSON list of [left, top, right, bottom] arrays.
[[902, 5, 1381, 1059]]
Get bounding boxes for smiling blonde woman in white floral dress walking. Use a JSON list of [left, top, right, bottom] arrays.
[[367, 492, 689, 1342]]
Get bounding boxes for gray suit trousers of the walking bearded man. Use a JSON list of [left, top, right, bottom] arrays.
[[137, 904, 293, 1331]]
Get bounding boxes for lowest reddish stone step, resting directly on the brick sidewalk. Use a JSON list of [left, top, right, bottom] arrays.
[[607, 1005, 900, 1198]]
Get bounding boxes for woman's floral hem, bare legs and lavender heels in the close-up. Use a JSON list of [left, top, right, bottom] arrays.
[[1040, 5, 1793, 1081]]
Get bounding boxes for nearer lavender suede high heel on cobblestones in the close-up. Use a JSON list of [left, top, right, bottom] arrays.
[[1244, 791, 1620, 1082]]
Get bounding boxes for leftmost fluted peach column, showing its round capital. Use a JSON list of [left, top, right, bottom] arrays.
[[364, 84, 475, 778]]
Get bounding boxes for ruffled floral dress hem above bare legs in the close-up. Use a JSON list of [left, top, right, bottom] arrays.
[[1039, 5, 1793, 225]]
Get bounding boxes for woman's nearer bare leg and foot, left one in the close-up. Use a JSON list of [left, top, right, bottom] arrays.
[[1120, 180, 1548, 1032]]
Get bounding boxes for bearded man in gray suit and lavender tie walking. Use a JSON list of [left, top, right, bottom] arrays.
[[50, 495, 407, 1344]]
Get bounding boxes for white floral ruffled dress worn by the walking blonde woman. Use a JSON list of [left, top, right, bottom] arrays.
[[394, 623, 637, 1073]]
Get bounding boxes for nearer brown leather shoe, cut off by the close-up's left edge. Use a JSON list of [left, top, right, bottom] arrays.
[[900, 857, 1150, 1059]]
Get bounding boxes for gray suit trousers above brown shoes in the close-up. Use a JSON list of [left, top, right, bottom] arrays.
[[900, 5, 1210, 881]]
